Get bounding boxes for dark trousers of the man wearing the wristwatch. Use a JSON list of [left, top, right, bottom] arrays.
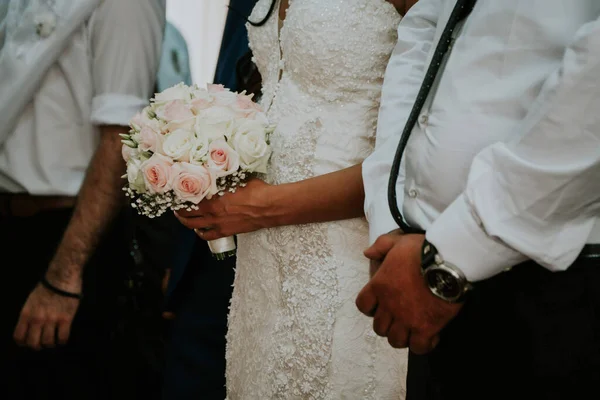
[[407, 250, 600, 400]]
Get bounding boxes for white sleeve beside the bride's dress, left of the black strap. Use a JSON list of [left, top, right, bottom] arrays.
[[362, 0, 443, 242]]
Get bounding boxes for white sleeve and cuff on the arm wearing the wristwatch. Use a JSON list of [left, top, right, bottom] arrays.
[[427, 20, 600, 281]]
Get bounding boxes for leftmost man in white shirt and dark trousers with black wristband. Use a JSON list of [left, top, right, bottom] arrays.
[[0, 0, 165, 399]]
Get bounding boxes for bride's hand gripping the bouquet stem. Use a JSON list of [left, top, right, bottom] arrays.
[[175, 179, 276, 240]]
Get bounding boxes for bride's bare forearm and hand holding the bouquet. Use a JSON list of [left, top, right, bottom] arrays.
[[176, 164, 365, 240]]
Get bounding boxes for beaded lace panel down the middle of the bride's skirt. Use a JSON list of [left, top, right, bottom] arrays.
[[268, 225, 338, 399]]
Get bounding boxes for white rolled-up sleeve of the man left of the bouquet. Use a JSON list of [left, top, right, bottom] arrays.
[[90, 0, 165, 126]]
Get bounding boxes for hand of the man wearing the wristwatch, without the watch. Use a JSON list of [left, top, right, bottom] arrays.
[[356, 232, 462, 354]]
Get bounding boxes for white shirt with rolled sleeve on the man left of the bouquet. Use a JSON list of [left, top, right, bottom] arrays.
[[0, 0, 165, 195]]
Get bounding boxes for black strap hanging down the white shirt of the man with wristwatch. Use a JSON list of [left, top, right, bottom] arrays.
[[388, 0, 477, 233]]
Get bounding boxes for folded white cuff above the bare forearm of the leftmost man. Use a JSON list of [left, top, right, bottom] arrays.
[[90, 93, 150, 126]]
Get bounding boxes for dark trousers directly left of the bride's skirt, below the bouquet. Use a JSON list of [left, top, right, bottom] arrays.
[[163, 240, 235, 400]]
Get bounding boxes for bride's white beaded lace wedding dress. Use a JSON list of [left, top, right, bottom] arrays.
[[227, 0, 407, 400]]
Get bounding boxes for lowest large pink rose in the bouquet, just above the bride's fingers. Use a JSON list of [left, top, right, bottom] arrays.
[[171, 162, 217, 204]]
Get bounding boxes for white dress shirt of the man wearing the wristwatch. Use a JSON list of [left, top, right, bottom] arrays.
[[363, 0, 600, 281]]
